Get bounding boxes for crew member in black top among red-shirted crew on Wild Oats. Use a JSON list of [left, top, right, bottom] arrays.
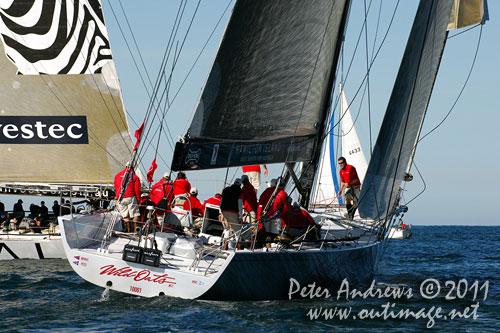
[[220, 178, 243, 237]]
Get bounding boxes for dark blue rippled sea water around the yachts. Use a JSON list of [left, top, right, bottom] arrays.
[[0, 226, 500, 332]]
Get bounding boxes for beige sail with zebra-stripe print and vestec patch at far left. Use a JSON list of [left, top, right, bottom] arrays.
[[0, 0, 132, 184]]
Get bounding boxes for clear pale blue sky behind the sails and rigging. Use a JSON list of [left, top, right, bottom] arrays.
[[2, 0, 500, 225]]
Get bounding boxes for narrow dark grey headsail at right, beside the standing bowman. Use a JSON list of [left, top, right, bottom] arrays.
[[359, 0, 453, 219]]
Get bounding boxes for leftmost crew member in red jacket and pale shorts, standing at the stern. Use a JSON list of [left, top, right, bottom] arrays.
[[114, 162, 141, 232]]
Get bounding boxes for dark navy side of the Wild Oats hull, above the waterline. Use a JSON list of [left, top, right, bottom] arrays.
[[200, 242, 381, 300]]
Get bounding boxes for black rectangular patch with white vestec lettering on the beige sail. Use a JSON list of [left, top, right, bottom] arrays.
[[0, 116, 89, 144]]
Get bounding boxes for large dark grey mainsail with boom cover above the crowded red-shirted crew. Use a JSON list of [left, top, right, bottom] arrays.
[[172, 0, 347, 170]]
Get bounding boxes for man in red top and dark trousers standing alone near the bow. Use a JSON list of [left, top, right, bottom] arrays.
[[337, 156, 361, 220]]
